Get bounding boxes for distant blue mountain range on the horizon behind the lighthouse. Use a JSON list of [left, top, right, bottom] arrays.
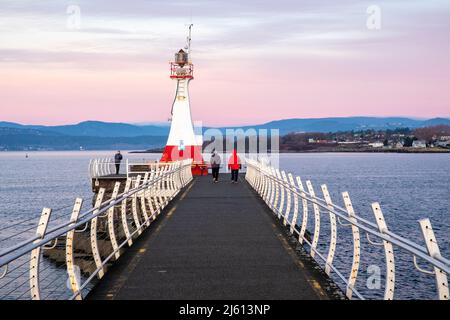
[[0, 117, 450, 150]]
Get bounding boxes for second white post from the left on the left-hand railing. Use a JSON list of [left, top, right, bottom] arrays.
[[66, 198, 83, 300]]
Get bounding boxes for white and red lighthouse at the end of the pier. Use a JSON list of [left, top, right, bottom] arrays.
[[161, 25, 208, 175]]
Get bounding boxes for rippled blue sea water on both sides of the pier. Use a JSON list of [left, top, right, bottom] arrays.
[[0, 151, 450, 299]]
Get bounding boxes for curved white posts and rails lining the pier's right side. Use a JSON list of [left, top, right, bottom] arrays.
[[245, 159, 450, 300]]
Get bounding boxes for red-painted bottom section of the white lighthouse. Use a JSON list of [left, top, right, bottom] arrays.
[[160, 146, 208, 176]]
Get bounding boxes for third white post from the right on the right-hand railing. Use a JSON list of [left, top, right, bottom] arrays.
[[342, 192, 361, 299]]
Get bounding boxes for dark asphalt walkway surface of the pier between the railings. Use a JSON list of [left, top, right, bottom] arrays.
[[88, 175, 329, 299]]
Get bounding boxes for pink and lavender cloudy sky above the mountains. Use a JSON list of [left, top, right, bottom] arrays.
[[0, 0, 450, 126]]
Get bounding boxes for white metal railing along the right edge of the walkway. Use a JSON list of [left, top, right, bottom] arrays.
[[246, 159, 450, 299]]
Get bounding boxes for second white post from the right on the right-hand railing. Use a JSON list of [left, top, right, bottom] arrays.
[[372, 202, 395, 300]]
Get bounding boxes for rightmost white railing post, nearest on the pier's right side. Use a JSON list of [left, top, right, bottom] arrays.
[[419, 219, 449, 300]]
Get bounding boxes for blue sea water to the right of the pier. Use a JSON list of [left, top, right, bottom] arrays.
[[280, 153, 450, 299]]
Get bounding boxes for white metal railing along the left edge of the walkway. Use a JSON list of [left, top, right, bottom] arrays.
[[0, 160, 192, 299]]
